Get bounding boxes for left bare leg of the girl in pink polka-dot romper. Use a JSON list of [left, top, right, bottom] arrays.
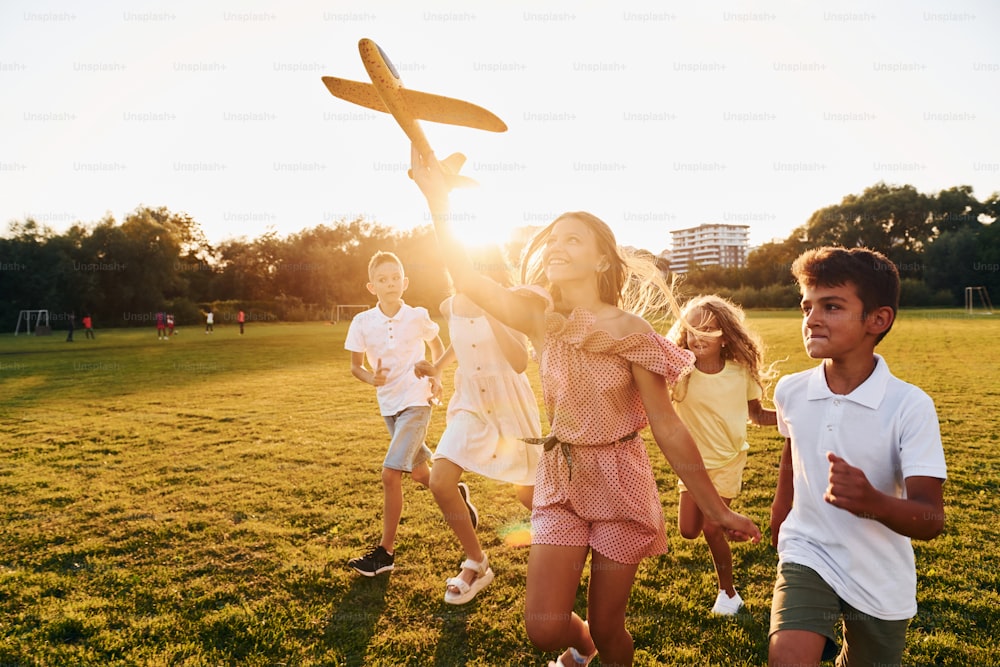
[[524, 544, 595, 655]]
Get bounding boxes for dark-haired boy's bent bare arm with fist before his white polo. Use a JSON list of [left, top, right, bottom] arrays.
[[823, 452, 944, 540]]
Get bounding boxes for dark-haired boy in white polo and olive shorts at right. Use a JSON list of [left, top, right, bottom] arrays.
[[768, 247, 946, 667]]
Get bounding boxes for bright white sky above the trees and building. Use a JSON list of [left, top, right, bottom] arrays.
[[0, 0, 1000, 252]]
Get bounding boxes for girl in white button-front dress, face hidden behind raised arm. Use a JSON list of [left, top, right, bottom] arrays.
[[417, 246, 541, 604]]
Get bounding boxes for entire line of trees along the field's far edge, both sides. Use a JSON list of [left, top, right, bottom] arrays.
[[0, 183, 1000, 331]]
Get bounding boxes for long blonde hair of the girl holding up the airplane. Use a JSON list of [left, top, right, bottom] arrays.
[[521, 211, 680, 323]]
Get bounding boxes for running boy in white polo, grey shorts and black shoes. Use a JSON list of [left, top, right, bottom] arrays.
[[344, 252, 444, 577]]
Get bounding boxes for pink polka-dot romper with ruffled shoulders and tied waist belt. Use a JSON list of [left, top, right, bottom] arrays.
[[522, 288, 694, 563]]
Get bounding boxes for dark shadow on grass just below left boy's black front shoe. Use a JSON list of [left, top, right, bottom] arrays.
[[324, 574, 392, 665]]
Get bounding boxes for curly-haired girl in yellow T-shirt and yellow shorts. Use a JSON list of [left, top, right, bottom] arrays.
[[667, 295, 777, 616]]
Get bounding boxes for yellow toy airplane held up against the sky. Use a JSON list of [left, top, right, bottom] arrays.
[[323, 39, 507, 187]]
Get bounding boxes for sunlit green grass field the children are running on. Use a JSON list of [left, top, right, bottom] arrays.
[[0, 311, 1000, 666]]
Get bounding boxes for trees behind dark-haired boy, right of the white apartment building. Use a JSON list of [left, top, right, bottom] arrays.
[[683, 182, 1000, 308]]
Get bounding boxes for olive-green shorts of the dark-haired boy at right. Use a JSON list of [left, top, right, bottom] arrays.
[[768, 563, 909, 667]]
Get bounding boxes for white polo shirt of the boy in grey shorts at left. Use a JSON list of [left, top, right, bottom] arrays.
[[344, 303, 440, 417]]
